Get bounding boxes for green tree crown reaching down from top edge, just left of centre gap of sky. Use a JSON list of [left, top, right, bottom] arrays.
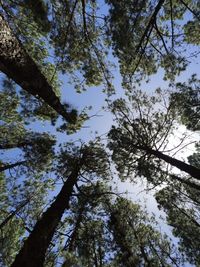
[[47, 1, 111, 91]]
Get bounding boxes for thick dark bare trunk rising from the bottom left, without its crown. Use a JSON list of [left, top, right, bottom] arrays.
[[11, 166, 80, 267]]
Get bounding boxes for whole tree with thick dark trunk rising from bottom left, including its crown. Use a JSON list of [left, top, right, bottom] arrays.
[[11, 141, 111, 267]]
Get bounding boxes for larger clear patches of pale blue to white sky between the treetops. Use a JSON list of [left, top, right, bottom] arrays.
[[49, 36, 200, 267]]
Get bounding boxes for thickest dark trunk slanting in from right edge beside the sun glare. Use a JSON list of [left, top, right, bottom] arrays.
[[133, 145, 200, 180]]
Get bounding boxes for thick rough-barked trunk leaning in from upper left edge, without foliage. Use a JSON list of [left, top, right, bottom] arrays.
[[0, 14, 75, 123]]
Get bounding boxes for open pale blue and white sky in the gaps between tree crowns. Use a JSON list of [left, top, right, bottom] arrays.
[[1, 2, 200, 267]]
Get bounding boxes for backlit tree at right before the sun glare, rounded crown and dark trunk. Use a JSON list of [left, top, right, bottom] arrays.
[[108, 91, 200, 186]]
